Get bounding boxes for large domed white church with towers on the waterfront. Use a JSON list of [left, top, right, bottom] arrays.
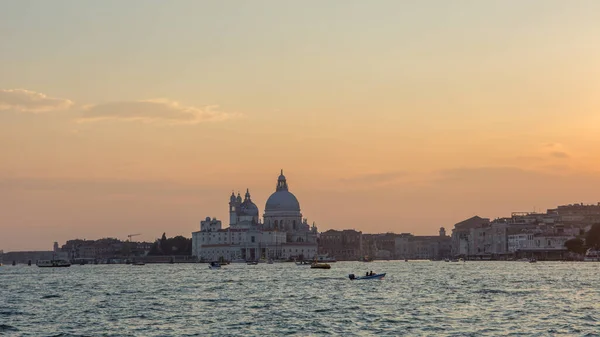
[[192, 170, 317, 261]]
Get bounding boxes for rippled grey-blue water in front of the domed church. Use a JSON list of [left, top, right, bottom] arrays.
[[0, 261, 600, 336]]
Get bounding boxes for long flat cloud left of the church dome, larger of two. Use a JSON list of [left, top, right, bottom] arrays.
[[79, 100, 237, 125]]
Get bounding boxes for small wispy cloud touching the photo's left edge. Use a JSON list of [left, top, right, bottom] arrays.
[[0, 89, 74, 112]]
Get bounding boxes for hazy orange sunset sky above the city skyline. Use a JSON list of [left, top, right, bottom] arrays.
[[0, 0, 600, 252]]
